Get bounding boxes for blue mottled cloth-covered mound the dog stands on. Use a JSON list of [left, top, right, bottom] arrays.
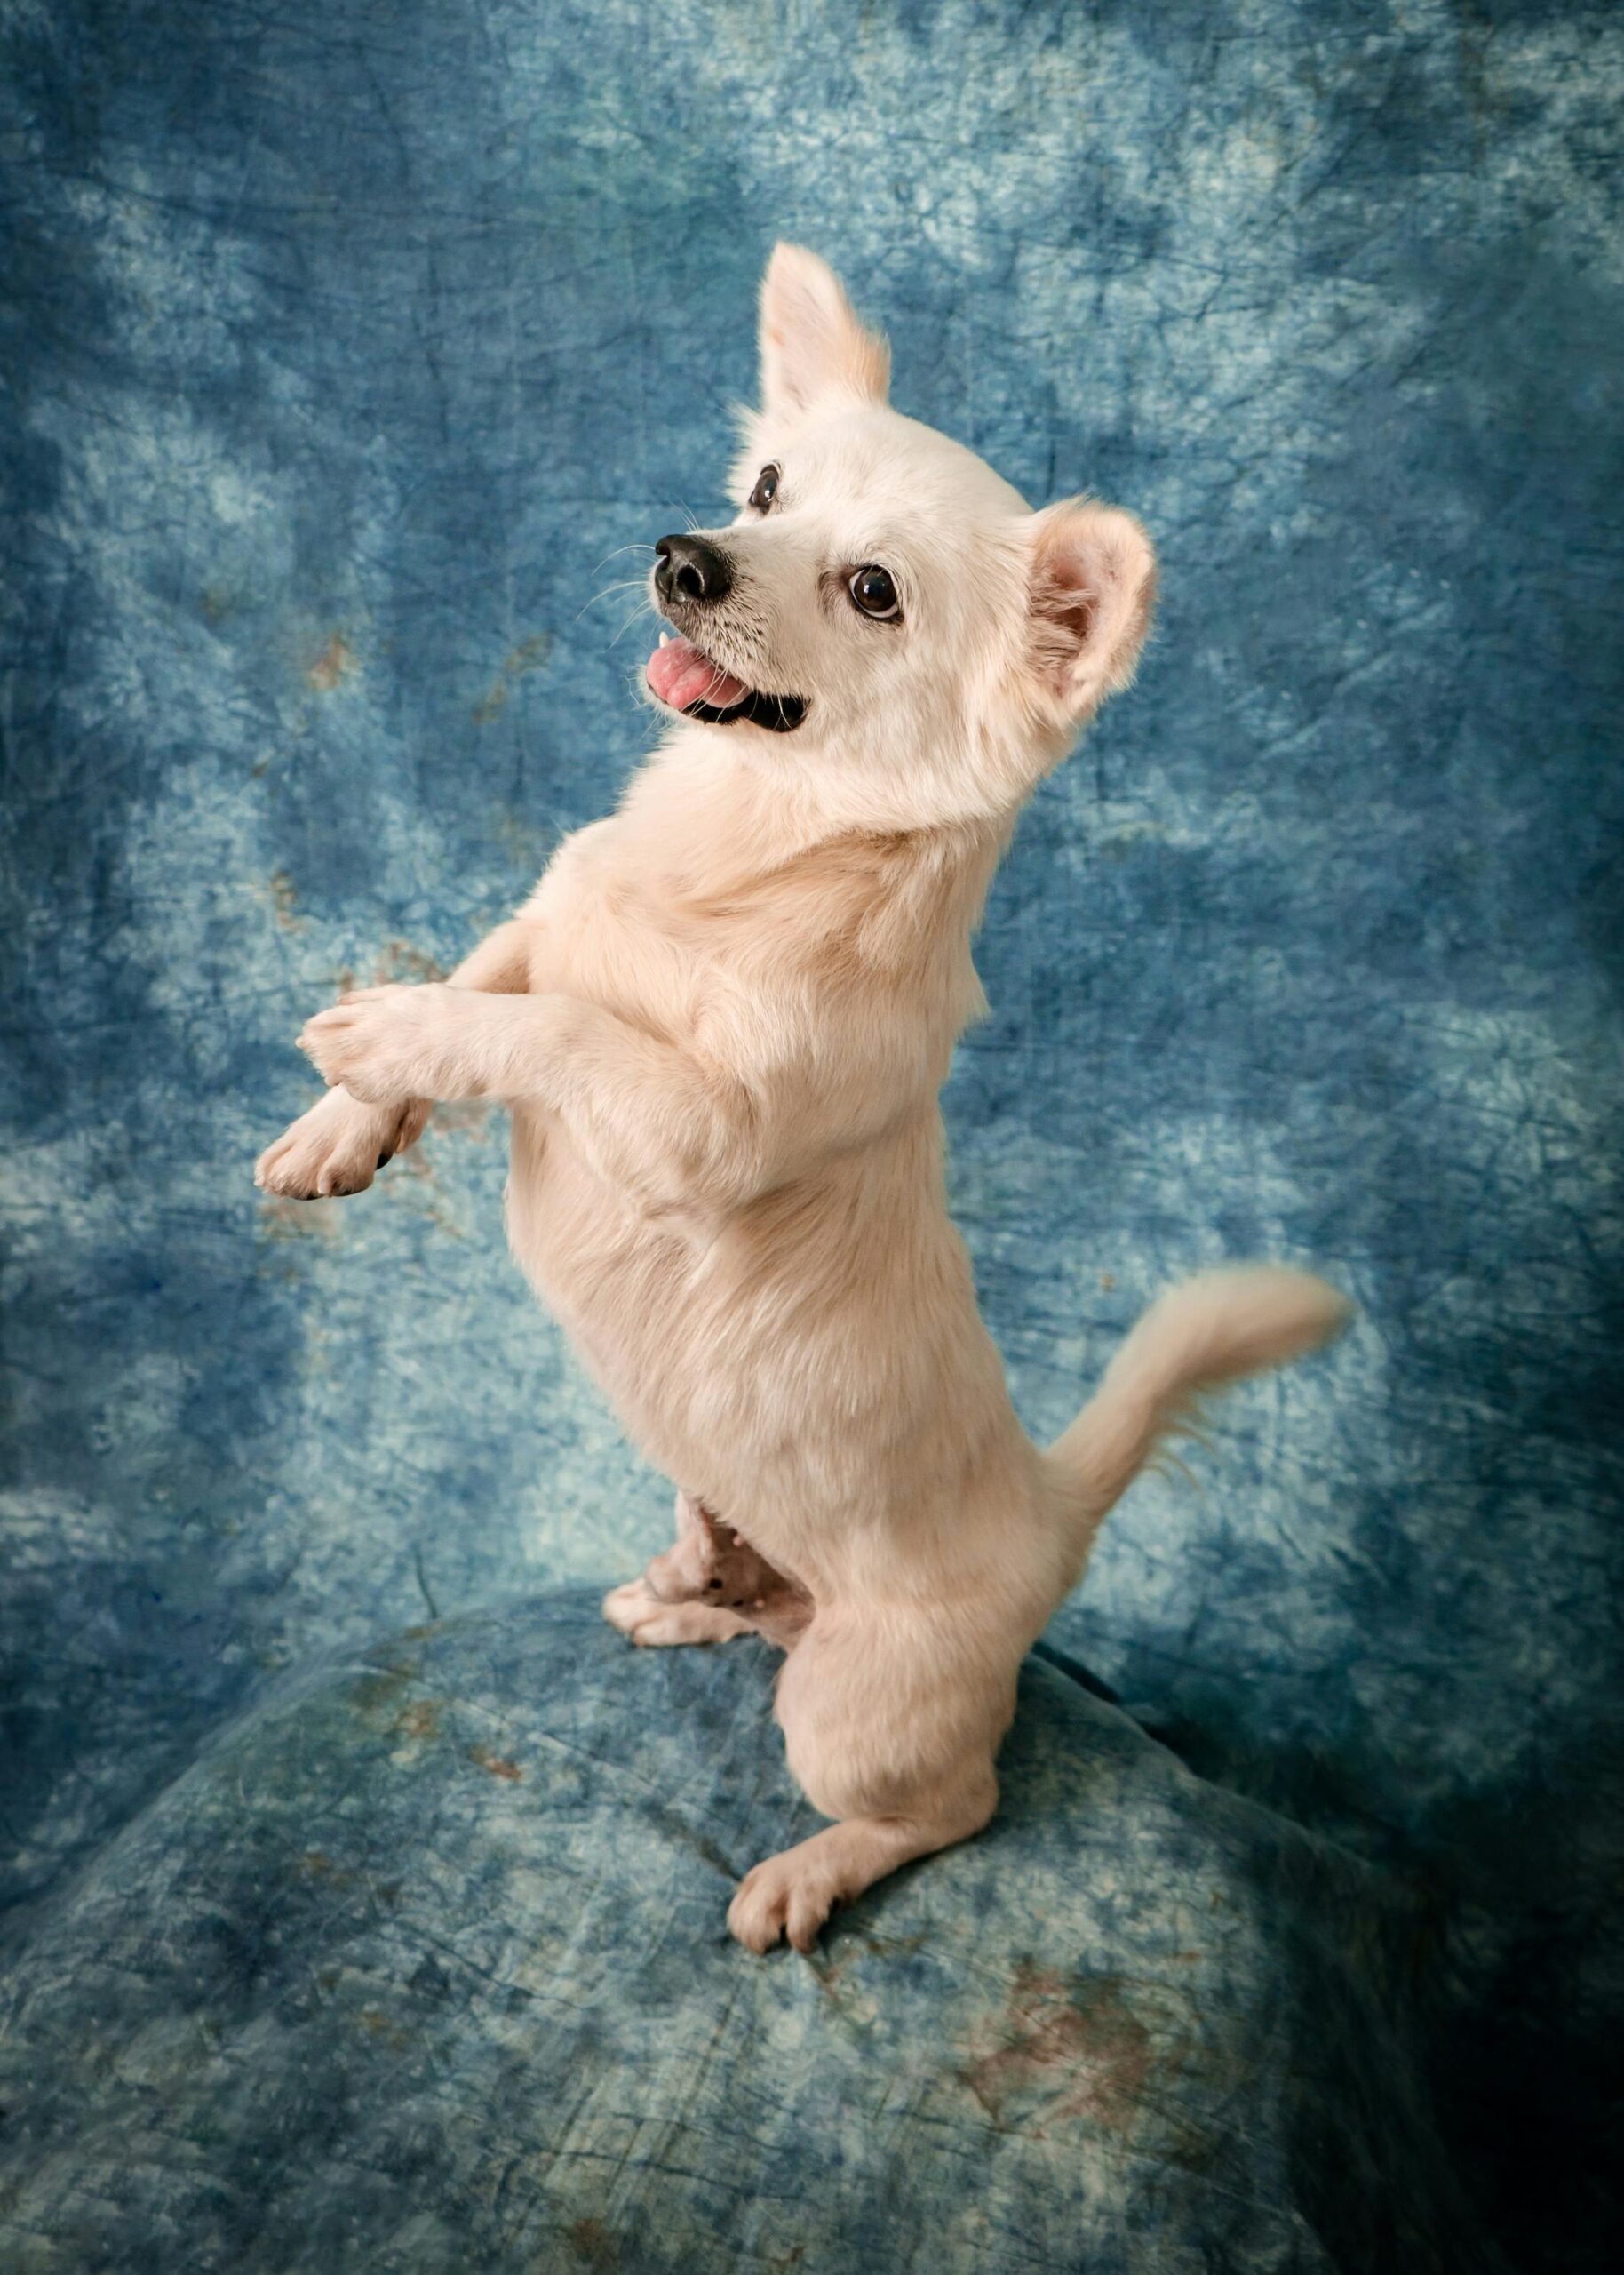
[[0, 1595, 1483, 2275]]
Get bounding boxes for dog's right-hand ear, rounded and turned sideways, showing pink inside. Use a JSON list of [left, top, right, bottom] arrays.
[[1028, 499, 1156, 726]]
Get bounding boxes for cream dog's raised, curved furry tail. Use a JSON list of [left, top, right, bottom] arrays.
[[1044, 1265, 1353, 1569]]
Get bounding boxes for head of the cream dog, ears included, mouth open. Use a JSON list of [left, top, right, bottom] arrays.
[[646, 245, 1156, 826]]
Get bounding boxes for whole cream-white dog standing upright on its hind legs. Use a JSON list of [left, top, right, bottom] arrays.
[[257, 245, 1347, 1952]]
